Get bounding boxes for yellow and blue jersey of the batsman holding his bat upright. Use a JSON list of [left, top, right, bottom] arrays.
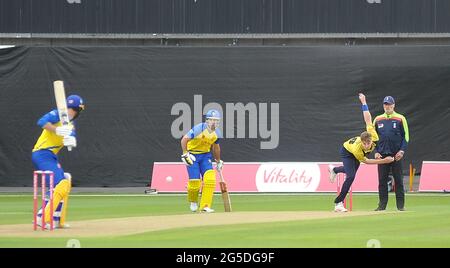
[[33, 109, 75, 155]]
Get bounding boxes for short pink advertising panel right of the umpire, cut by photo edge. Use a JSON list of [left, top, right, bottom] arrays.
[[419, 161, 450, 192]]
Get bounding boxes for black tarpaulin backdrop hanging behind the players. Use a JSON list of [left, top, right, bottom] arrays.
[[0, 46, 450, 186]]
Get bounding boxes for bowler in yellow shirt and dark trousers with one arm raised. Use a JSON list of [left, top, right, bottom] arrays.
[[328, 93, 394, 212]]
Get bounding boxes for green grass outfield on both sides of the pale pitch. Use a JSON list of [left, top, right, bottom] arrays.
[[0, 194, 450, 248]]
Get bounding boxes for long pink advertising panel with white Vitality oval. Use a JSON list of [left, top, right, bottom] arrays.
[[151, 162, 378, 193]]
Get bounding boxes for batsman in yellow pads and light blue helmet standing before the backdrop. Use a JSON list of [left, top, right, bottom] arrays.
[[181, 110, 223, 213]]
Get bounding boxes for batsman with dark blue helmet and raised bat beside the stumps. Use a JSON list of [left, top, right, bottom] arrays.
[[31, 95, 84, 228]]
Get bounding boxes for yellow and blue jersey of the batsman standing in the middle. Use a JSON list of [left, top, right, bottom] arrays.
[[186, 123, 221, 154]]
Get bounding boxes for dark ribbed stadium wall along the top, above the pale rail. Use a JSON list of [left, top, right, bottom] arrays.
[[0, 0, 450, 34]]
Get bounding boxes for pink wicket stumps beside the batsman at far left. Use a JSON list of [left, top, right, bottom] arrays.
[[33, 170, 54, 231]]
